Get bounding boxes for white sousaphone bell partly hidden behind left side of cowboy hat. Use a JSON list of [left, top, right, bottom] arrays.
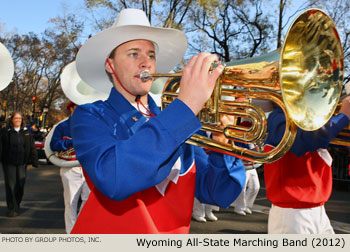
[[61, 61, 108, 105]]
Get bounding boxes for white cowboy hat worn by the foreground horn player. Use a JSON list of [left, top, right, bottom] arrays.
[[76, 9, 187, 93]]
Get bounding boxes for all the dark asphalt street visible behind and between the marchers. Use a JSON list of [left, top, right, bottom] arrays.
[[0, 161, 350, 234]]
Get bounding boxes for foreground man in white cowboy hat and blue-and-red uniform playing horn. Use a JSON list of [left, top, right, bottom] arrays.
[[71, 9, 245, 233]]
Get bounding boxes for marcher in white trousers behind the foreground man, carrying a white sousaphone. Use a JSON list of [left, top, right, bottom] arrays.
[[50, 102, 90, 234]]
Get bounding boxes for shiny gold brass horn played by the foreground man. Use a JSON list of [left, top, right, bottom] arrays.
[[141, 9, 344, 163]]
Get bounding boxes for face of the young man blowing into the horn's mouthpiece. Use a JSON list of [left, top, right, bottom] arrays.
[[106, 40, 156, 96]]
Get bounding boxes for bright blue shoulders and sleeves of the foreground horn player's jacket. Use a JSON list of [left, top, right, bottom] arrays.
[[71, 88, 245, 207]]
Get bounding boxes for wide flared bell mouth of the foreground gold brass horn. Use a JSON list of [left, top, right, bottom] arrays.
[[280, 10, 344, 131]]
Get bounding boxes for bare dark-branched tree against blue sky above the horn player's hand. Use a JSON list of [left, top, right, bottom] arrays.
[[190, 0, 272, 61]]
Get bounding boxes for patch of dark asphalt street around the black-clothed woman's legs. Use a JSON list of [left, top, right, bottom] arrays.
[[0, 161, 65, 234]]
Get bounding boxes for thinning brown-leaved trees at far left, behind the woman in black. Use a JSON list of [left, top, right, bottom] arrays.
[[0, 12, 82, 126]]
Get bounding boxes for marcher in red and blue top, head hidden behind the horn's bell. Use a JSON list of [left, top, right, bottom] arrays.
[[264, 97, 350, 234]]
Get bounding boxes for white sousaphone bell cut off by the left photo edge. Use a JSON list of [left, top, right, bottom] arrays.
[[0, 43, 15, 91]]
